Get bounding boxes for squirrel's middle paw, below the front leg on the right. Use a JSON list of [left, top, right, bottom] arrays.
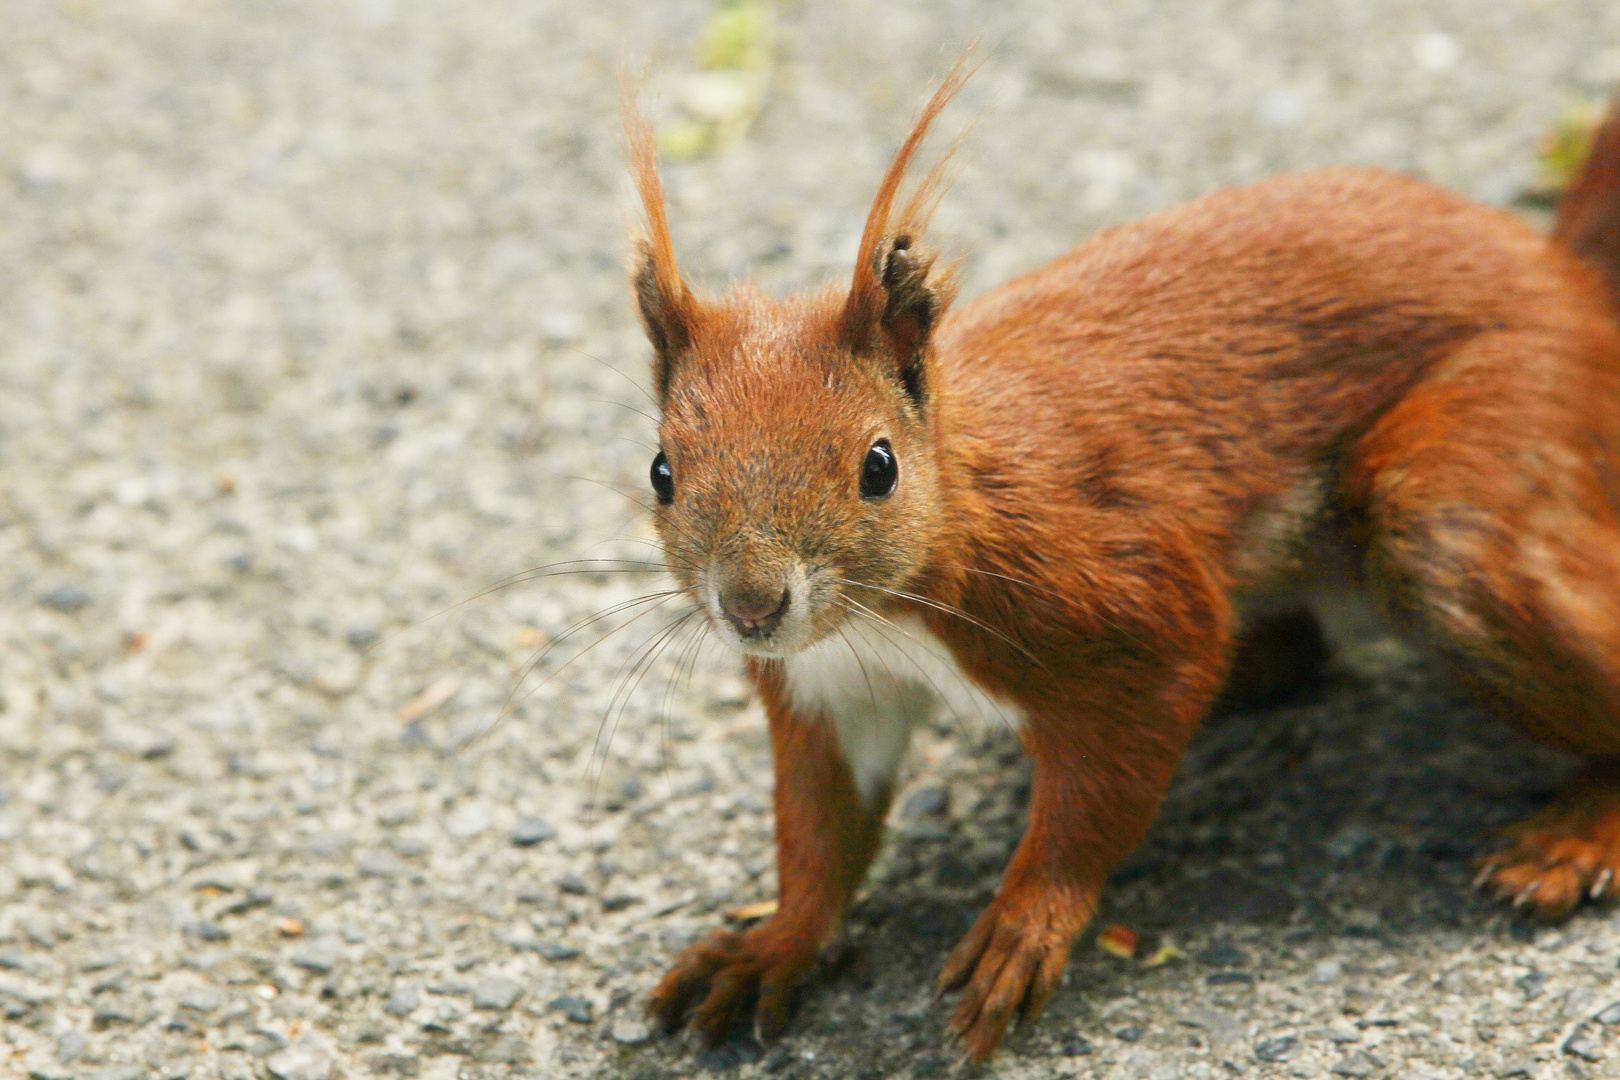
[[938, 897, 1076, 1061]]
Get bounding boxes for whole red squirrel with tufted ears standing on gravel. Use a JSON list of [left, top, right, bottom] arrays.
[[624, 63, 1620, 1061]]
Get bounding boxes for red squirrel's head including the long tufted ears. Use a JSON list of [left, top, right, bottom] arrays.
[[622, 62, 966, 657]]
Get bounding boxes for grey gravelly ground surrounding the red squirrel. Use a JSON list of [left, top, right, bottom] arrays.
[[9, 0, 1620, 1080]]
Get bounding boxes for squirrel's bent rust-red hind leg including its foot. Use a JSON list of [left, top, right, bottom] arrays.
[[1349, 334, 1620, 916]]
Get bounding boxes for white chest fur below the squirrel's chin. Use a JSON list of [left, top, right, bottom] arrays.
[[784, 615, 1024, 800]]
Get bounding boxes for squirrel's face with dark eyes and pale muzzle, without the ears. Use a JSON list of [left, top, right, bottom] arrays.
[[643, 288, 941, 657]]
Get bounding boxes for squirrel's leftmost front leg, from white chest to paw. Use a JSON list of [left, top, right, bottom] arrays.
[[648, 670, 889, 1046]]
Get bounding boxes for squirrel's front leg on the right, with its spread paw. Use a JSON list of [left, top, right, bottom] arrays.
[[938, 670, 1218, 1061]]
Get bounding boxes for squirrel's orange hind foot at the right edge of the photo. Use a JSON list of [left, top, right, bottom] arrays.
[[1474, 759, 1620, 918]]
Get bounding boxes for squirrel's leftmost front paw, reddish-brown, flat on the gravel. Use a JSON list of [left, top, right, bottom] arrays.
[[646, 923, 815, 1046]]
